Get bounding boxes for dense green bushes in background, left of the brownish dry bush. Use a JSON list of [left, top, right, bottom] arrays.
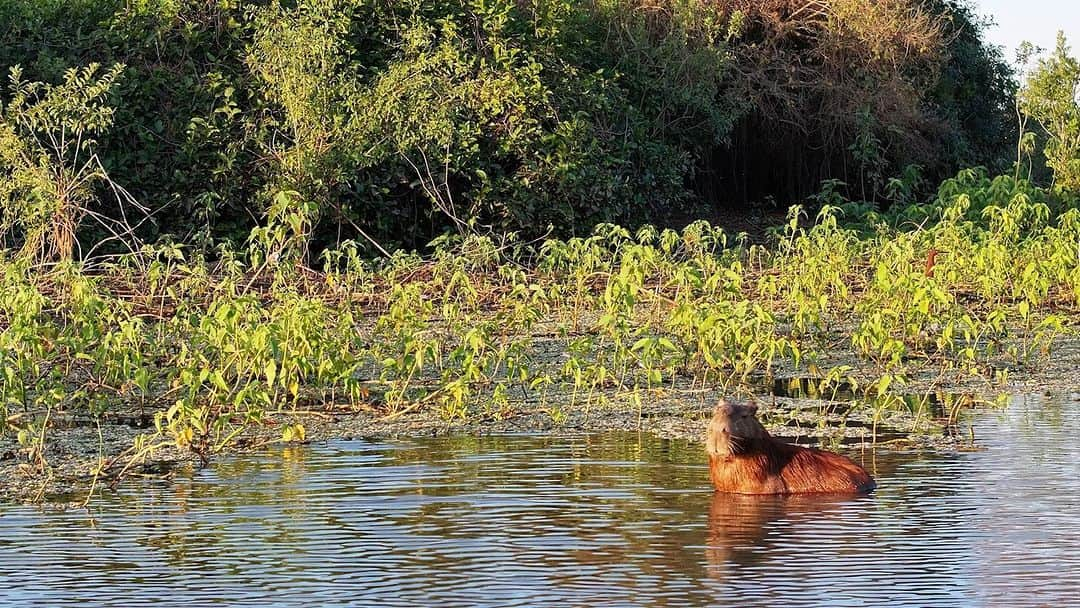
[[0, 0, 737, 248]]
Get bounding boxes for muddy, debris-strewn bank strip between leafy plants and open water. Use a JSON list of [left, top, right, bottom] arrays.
[[0, 339, 1080, 506]]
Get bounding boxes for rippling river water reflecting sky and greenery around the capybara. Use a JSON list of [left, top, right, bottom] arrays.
[[0, 394, 1080, 607]]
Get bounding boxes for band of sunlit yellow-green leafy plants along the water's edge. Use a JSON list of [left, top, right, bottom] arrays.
[[0, 166, 1080, 485]]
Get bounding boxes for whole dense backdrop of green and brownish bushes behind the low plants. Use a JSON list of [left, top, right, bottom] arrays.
[[0, 0, 1028, 254]]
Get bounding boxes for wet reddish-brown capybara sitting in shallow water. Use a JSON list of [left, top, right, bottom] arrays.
[[705, 400, 877, 494]]
